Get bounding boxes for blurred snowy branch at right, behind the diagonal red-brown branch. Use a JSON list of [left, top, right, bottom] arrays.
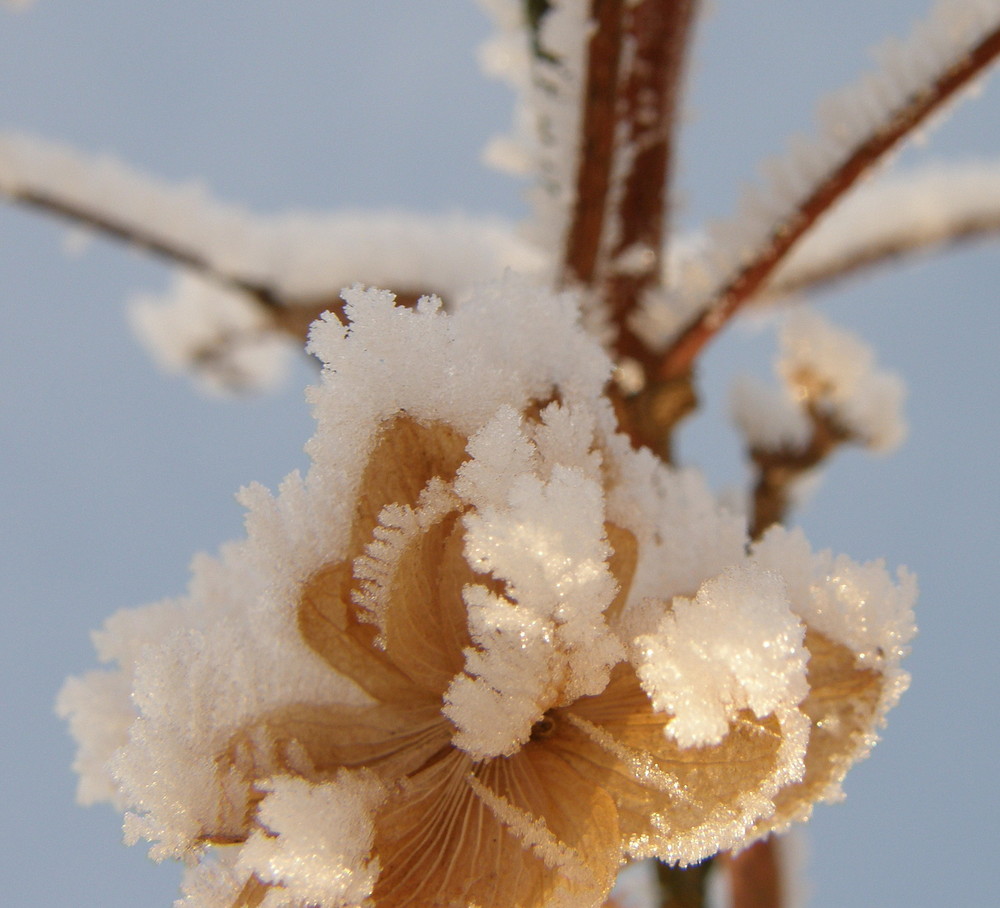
[[764, 161, 1000, 296]]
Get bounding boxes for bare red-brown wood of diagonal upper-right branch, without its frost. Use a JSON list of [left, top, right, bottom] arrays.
[[660, 17, 1000, 377]]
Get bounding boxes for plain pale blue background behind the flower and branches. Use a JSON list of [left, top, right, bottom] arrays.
[[0, 0, 1000, 908]]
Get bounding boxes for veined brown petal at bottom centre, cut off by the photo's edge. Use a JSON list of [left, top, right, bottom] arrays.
[[373, 749, 618, 908]]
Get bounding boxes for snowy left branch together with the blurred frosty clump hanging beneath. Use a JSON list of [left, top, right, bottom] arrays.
[[0, 134, 541, 393]]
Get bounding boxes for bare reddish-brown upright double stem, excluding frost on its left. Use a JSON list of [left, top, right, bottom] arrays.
[[563, 0, 697, 365]]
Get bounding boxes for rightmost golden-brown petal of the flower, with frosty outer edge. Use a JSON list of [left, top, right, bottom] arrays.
[[755, 629, 885, 833]]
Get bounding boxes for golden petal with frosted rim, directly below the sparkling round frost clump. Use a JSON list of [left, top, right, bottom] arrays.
[[551, 664, 782, 863]]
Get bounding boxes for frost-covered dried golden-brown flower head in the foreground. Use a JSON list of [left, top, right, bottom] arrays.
[[54, 278, 914, 908]]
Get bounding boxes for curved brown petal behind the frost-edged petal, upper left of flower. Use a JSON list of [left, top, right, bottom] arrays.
[[298, 415, 466, 700]]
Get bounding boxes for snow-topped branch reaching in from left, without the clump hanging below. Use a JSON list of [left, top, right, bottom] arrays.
[[0, 127, 539, 326]]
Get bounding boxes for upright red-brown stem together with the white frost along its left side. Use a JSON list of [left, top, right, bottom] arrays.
[[484, 0, 698, 359]]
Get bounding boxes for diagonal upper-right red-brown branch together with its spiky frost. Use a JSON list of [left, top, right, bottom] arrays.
[[661, 0, 1000, 376]]
